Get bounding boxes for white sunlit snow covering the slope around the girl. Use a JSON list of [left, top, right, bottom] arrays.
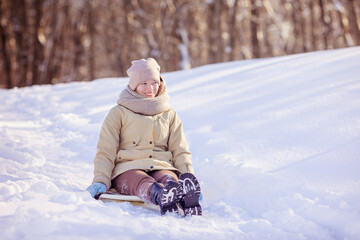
[[0, 47, 360, 239]]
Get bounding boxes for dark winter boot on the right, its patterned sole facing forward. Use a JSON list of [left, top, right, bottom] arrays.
[[177, 173, 202, 216]]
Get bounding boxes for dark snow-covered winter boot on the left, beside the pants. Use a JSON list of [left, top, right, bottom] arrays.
[[150, 181, 178, 215]]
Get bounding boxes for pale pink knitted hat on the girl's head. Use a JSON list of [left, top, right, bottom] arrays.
[[127, 58, 160, 90]]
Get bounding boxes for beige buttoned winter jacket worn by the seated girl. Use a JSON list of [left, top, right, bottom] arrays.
[[93, 105, 194, 189]]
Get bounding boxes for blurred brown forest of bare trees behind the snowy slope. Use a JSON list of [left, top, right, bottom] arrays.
[[0, 0, 360, 88]]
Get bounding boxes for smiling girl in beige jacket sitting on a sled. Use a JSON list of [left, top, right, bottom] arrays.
[[87, 58, 202, 216]]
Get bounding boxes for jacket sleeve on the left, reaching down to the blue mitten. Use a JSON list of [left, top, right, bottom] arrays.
[[93, 108, 121, 189]]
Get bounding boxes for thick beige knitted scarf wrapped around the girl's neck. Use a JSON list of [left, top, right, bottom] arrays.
[[117, 84, 170, 116]]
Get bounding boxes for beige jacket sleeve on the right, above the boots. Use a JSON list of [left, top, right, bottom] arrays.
[[168, 112, 194, 174]]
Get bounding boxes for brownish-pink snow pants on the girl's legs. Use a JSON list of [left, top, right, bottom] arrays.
[[112, 169, 179, 203]]
